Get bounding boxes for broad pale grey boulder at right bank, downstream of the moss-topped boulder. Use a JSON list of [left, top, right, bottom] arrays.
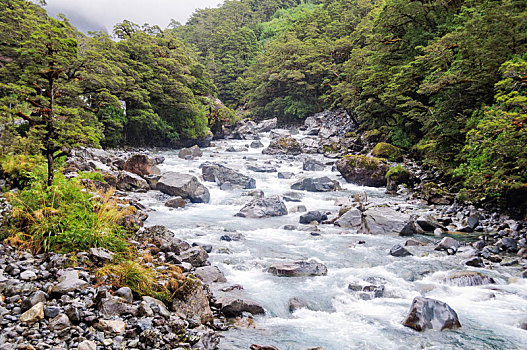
[[359, 207, 411, 235]]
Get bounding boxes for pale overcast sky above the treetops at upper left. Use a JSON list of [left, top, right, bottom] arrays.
[[44, 0, 223, 33]]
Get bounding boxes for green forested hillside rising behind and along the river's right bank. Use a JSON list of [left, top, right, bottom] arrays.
[[175, 0, 527, 211]]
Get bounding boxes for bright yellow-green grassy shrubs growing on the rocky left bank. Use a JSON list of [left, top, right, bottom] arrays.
[[2, 160, 128, 253]]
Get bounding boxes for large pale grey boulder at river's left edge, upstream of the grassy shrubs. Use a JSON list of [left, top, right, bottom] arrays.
[[157, 171, 210, 203]]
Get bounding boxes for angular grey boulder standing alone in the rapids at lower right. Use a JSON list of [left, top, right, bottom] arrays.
[[403, 297, 461, 332]]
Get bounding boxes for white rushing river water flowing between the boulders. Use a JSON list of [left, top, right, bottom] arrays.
[[137, 135, 527, 350]]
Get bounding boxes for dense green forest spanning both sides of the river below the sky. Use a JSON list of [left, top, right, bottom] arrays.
[[0, 0, 527, 211]]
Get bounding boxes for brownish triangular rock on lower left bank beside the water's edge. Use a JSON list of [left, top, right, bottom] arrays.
[[172, 283, 213, 324]]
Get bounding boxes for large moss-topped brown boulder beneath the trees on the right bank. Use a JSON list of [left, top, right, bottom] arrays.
[[337, 155, 388, 187]]
